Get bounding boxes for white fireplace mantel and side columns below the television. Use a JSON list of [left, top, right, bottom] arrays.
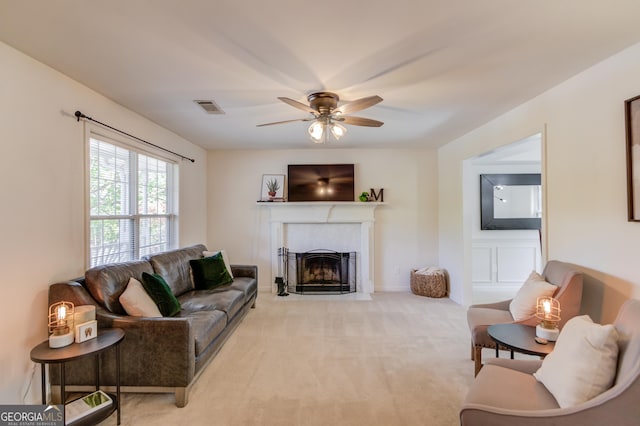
[[258, 201, 385, 294]]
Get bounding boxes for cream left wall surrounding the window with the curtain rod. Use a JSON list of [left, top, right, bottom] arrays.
[[0, 43, 207, 404]]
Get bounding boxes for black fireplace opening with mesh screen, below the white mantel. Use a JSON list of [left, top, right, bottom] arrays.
[[281, 249, 357, 294]]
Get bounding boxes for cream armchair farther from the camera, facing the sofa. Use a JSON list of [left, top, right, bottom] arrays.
[[467, 260, 582, 375]]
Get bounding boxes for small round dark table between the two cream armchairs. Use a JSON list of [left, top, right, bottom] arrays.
[[487, 324, 556, 359]]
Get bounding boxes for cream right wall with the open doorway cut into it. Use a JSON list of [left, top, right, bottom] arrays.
[[438, 44, 640, 321]]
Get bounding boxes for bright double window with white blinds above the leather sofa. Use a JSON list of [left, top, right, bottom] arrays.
[[89, 135, 177, 267]]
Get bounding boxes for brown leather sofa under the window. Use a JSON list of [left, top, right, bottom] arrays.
[[49, 245, 258, 407]]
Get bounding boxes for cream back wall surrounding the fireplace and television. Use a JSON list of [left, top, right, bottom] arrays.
[[207, 147, 438, 291]]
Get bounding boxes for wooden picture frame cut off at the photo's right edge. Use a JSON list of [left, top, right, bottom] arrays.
[[624, 95, 640, 222]]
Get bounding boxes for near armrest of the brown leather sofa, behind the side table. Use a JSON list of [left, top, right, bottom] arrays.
[[97, 310, 196, 387]]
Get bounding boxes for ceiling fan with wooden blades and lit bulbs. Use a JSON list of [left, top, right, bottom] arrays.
[[257, 92, 384, 143]]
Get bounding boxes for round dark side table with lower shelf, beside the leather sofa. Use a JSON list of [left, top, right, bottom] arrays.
[[31, 328, 124, 424]]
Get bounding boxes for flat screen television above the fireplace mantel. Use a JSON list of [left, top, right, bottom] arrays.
[[287, 164, 354, 201]]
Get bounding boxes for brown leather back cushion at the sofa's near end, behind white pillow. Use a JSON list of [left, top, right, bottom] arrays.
[[84, 260, 153, 315]]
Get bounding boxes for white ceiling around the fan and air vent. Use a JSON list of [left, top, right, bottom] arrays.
[[0, 0, 640, 149]]
